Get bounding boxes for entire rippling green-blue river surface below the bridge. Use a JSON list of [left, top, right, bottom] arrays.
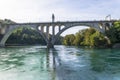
[[0, 46, 120, 80]]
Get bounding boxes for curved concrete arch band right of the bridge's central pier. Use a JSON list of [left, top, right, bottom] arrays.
[[52, 23, 102, 44]]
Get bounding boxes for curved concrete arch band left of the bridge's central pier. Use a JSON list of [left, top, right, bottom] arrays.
[[0, 25, 47, 46]]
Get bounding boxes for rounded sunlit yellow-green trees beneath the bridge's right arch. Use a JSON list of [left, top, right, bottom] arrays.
[[63, 28, 108, 47]]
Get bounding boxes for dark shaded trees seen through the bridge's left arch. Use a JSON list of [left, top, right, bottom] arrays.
[[6, 28, 46, 45]]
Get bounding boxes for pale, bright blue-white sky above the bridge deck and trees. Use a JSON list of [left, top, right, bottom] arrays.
[[0, 0, 120, 35]]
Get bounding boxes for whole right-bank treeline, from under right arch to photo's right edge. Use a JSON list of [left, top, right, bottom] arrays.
[[63, 22, 120, 47]]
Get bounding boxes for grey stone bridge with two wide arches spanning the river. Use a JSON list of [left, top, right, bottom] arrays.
[[0, 20, 117, 48]]
